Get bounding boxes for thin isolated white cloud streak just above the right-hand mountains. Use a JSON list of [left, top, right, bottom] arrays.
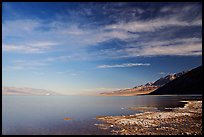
[[97, 63, 150, 68]]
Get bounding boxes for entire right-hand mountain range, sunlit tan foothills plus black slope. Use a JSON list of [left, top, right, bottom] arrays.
[[101, 66, 202, 96]]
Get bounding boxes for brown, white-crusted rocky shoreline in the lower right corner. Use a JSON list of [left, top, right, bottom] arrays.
[[96, 100, 202, 135]]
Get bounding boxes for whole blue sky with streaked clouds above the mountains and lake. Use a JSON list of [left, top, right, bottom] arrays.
[[2, 2, 202, 95]]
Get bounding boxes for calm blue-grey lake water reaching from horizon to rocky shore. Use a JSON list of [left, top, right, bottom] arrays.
[[2, 96, 201, 135]]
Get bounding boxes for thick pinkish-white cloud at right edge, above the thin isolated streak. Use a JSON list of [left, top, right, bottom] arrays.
[[124, 38, 202, 56]]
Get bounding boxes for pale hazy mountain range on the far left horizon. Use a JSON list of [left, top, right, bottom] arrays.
[[2, 87, 59, 96]]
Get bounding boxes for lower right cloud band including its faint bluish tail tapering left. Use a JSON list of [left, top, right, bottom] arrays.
[[93, 38, 202, 58]]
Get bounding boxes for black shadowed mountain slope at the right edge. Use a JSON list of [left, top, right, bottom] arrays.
[[149, 66, 202, 95]]
